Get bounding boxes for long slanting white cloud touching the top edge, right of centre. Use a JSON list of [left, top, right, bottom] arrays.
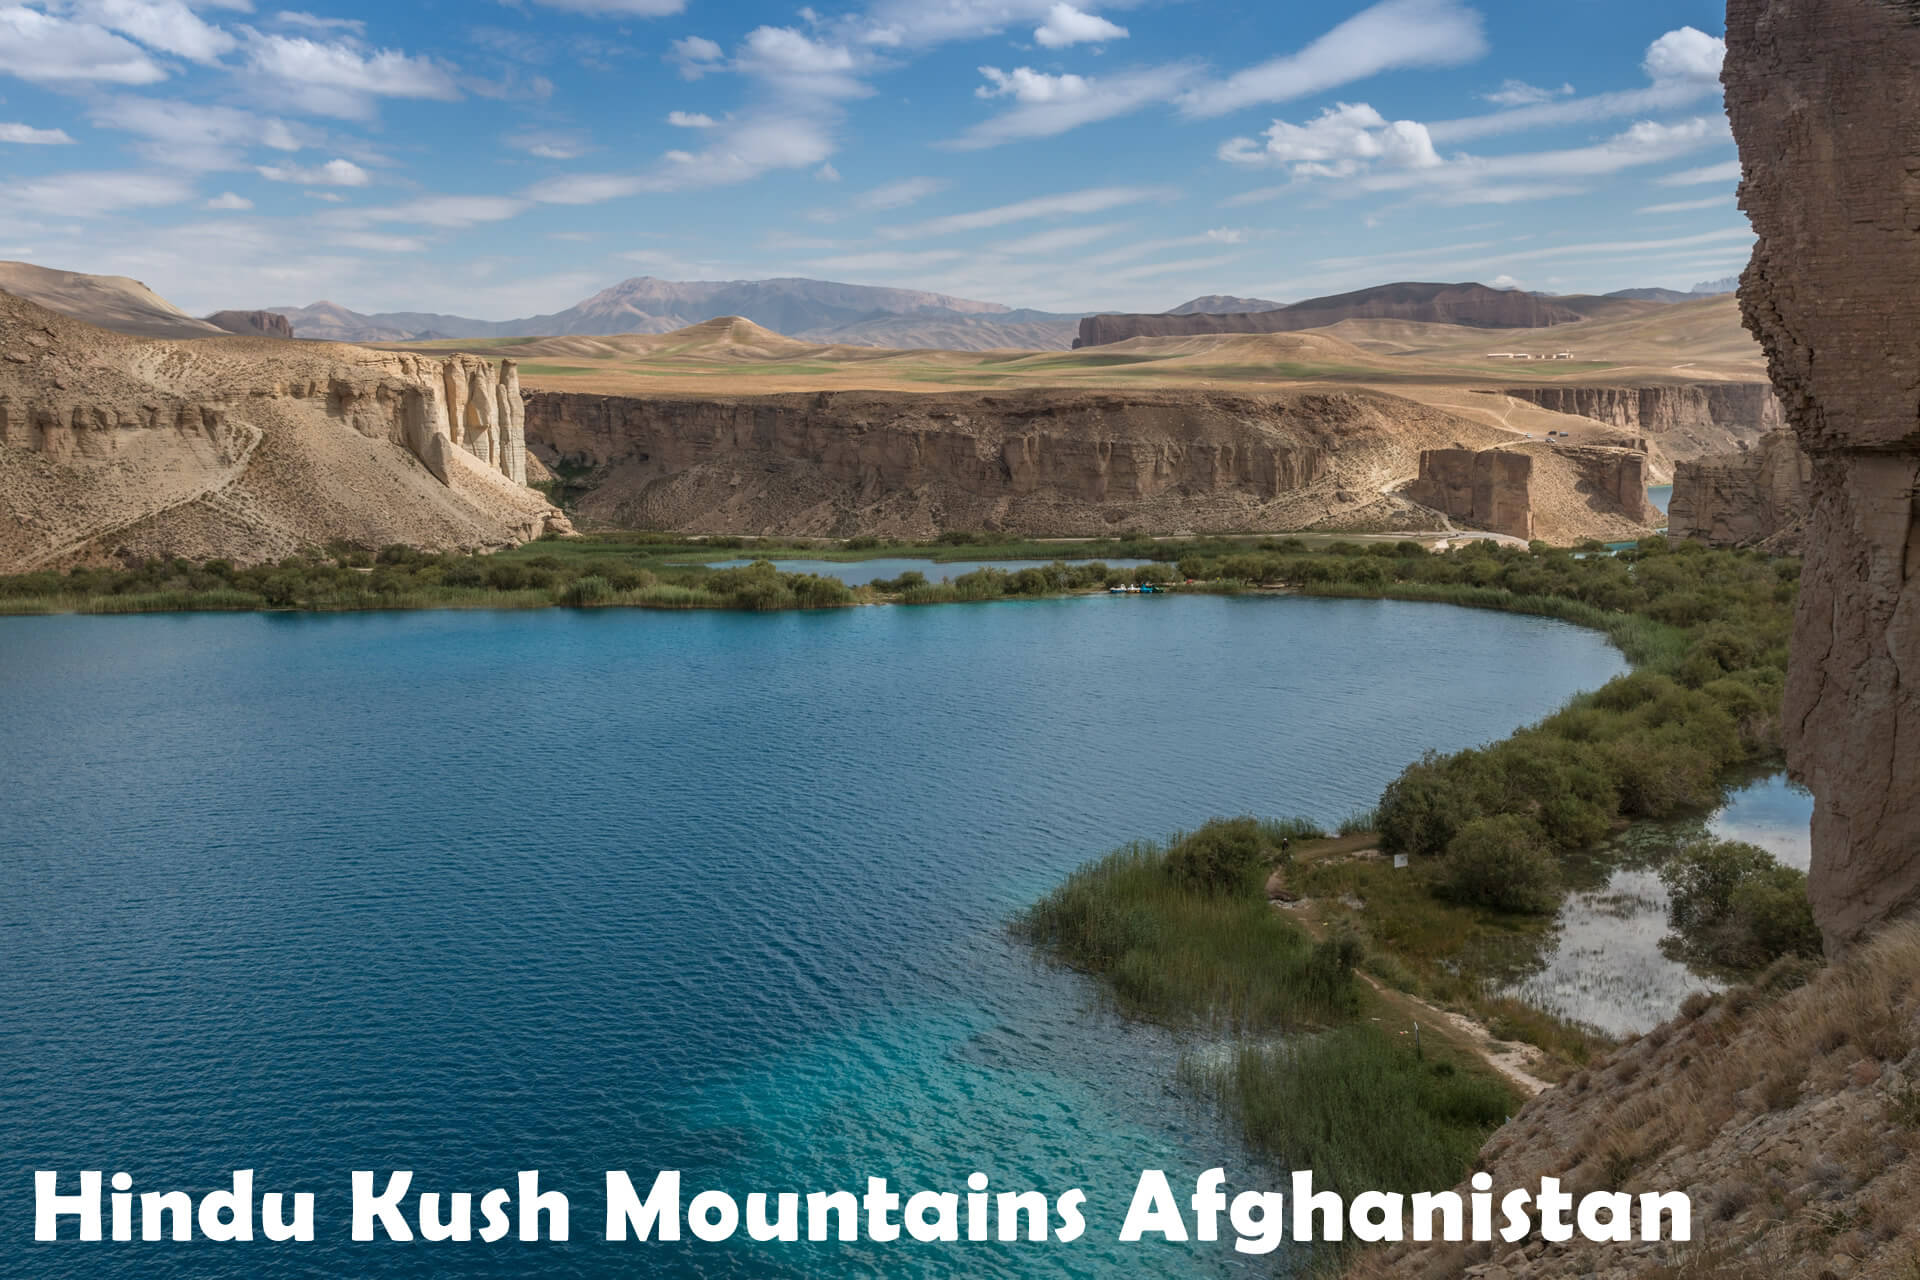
[[1181, 0, 1486, 117]]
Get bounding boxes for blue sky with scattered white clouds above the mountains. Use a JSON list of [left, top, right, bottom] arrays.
[[0, 0, 1751, 319]]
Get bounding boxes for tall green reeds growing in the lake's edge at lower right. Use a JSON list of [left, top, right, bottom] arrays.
[[1014, 818, 1515, 1190]]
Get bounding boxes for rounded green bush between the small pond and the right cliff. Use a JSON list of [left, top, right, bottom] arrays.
[[1661, 841, 1820, 971]]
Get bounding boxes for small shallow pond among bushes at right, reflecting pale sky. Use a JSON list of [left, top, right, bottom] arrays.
[[1511, 773, 1812, 1036]]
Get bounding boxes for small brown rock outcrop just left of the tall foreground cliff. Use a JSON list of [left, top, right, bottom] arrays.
[[1667, 432, 1812, 551]]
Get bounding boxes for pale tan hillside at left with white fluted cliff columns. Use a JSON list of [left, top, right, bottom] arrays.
[[0, 294, 564, 572]]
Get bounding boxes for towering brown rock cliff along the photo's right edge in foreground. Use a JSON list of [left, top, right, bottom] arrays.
[[1722, 0, 1920, 950]]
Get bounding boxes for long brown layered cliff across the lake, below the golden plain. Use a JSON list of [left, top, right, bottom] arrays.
[[526, 391, 1494, 535]]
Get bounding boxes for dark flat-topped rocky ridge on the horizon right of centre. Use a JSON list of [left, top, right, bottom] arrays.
[[1073, 284, 1586, 347]]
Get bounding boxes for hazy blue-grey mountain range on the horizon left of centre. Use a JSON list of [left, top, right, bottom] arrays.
[[269, 276, 1079, 351]]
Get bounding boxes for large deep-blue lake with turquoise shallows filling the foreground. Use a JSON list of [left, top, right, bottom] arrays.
[[0, 595, 1624, 1280]]
